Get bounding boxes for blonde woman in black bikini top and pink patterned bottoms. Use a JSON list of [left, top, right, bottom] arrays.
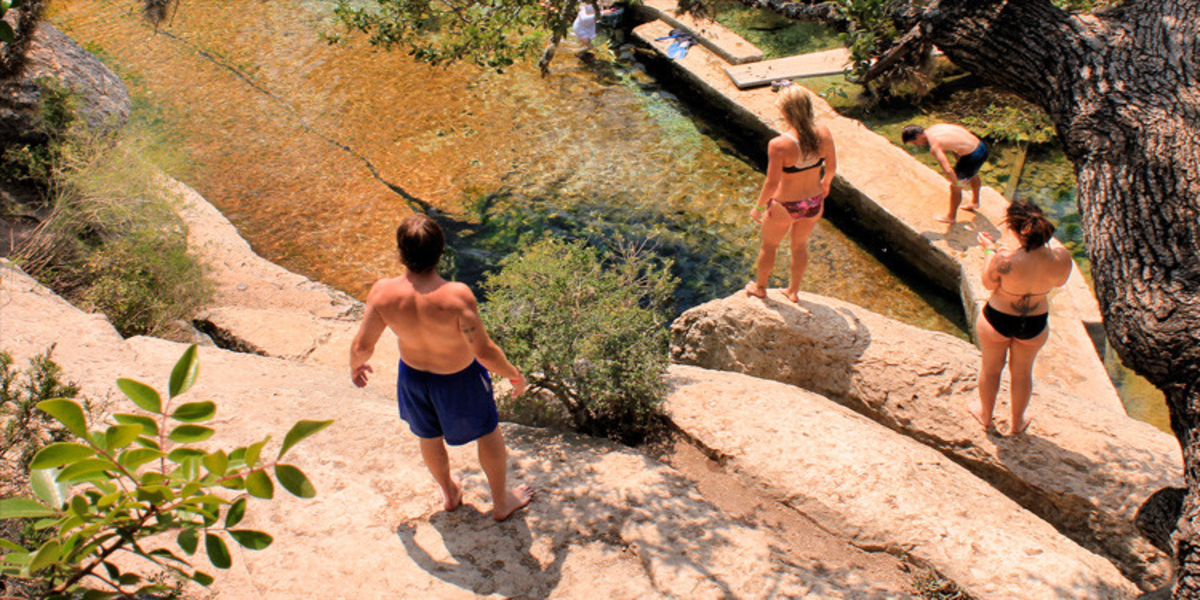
[[746, 85, 838, 302]]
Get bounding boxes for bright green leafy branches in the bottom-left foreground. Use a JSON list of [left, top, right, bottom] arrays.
[[0, 346, 332, 599]]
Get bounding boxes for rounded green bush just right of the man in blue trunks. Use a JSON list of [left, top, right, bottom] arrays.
[[484, 238, 676, 443]]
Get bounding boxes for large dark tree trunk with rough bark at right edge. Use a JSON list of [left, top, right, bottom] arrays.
[[923, 0, 1200, 598]]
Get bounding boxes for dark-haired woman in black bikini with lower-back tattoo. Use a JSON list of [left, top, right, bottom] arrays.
[[967, 202, 1073, 434]]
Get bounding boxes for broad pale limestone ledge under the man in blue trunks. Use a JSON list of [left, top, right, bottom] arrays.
[[0, 250, 898, 600]]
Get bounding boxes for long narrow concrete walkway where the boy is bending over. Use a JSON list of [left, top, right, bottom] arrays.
[[634, 22, 1124, 414]]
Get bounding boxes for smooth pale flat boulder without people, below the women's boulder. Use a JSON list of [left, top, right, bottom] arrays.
[[666, 365, 1136, 600]]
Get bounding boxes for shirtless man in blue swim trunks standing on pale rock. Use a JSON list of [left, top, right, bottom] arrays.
[[350, 215, 533, 521]]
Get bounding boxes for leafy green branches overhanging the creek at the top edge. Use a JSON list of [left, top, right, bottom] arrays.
[[328, 0, 559, 70]]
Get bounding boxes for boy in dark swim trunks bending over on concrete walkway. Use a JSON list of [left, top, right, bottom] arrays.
[[900, 122, 988, 223]]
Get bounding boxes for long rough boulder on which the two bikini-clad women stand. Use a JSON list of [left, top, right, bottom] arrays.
[[672, 292, 1182, 586]]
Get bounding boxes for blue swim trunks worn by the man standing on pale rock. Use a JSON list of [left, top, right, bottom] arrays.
[[396, 360, 500, 446]]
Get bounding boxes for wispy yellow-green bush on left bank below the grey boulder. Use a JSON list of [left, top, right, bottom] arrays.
[[14, 127, 211, 336]]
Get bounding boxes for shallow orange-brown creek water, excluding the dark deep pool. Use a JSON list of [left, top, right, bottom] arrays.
[[50, 0, 1161, 432]]
